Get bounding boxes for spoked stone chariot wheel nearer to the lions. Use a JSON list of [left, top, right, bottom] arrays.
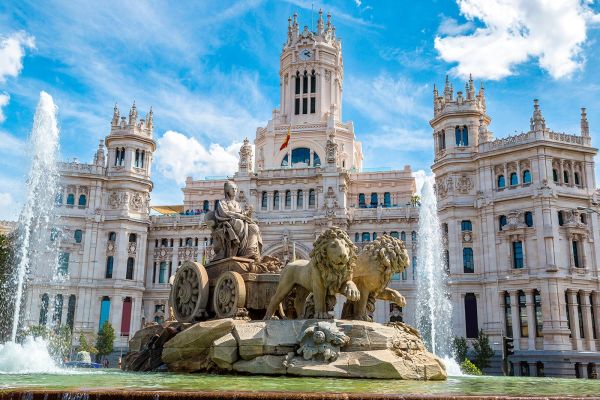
[[213, 271, 246, 318]]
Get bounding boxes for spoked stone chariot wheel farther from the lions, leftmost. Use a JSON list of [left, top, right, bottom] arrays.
[[170, 261, 208, 322]]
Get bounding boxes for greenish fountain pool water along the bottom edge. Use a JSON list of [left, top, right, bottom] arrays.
[[0, 369, 600, 396]]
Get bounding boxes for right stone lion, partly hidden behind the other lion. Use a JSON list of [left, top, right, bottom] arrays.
[[342, 235, 409, 321]]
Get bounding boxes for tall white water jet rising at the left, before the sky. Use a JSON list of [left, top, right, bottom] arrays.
[[11, 92, 58, 342]]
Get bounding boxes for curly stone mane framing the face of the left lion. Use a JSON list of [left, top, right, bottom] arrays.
[[310, 227, 357, 295]]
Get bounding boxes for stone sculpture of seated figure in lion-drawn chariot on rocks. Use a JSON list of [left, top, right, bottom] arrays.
[[124, 182, 447, 380]]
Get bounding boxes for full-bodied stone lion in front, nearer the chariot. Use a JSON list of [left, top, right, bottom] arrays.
[[265, 227, 360, 319]]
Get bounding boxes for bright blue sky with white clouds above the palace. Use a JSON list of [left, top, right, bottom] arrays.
[[0, 0, 600, 219]]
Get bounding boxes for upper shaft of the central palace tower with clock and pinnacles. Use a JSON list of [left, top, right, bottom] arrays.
[[280, 11, 344, 125]]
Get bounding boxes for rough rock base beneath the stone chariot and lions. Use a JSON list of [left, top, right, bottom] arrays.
[[128, 319, 447, 380]]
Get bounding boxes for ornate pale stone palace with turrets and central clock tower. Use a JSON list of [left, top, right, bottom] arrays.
[[27, 13, 600, 377]]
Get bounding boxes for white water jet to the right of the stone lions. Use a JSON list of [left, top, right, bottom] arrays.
[[416, 176, 453, 362]]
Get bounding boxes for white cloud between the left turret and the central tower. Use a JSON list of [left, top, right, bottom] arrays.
[[155, 131, 242, 184]]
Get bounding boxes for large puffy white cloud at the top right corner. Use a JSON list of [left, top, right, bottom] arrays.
[[435, 0, 599, 80]]
